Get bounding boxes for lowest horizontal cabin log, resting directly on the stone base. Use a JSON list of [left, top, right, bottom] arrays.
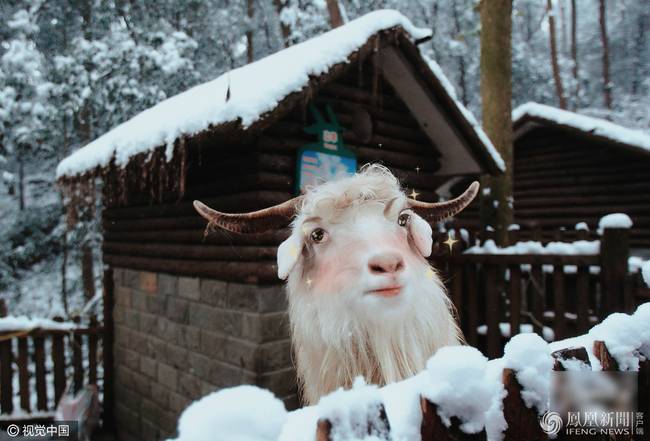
[[104, 254, 280, 284]]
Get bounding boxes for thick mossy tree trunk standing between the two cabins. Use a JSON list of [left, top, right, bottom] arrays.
[[480, 0, 512, 245]]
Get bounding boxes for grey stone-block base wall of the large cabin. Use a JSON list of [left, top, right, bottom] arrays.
[[113, 268, 298, 441]]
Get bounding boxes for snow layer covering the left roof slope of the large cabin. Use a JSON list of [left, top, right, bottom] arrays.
[[56, 10, 431, 178]]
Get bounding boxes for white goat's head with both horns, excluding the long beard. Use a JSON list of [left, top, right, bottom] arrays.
[[195, 164, 478, 312]]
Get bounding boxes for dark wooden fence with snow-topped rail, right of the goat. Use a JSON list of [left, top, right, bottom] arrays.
[[433, 223, 650, 357]]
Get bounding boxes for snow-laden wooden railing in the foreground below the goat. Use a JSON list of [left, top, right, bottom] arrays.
[[168, 303, 650, 441]]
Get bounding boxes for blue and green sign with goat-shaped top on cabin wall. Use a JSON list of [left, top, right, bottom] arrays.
[[296, 105, 357, 193]]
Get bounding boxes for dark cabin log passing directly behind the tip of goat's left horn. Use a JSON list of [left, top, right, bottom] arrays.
[[103, 191, 293, 219]]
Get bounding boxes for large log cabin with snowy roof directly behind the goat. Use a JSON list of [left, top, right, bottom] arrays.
[[57, 11, 504, 440]]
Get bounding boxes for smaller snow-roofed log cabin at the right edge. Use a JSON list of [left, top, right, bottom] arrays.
[[513, 103, 650, 251]]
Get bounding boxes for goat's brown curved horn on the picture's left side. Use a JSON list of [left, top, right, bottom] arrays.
[[194, 196, 302, 233]]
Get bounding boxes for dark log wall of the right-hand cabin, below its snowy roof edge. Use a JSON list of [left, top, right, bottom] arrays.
[[514, 127, 650, 248]]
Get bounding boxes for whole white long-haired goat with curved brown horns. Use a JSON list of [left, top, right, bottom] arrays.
[[194, 165, 478, 404]]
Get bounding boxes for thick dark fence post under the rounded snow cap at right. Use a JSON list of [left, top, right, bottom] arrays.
[[599, 228, 630, 319]]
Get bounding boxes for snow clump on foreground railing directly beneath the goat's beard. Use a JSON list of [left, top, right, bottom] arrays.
[[318, 377, 388, 441]]
